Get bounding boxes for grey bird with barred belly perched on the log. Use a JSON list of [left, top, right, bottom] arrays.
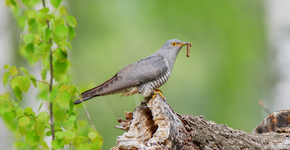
[[74, 39, 191, 104]]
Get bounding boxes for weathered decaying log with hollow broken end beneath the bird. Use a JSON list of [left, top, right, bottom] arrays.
[[111, 95, 290, 150]]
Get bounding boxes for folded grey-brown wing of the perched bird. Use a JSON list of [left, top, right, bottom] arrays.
[[82, 56, 169, 99]]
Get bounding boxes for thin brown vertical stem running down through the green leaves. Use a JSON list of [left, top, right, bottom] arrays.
[[42, 0, 55, 143]]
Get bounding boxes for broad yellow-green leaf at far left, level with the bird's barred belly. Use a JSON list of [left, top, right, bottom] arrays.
[[10, 76, 30, 93]]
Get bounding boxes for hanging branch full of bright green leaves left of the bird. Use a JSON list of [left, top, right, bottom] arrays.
[[0, 0, 103, 150]]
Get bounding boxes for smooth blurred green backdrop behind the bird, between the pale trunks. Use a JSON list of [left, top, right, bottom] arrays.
[[5, 0, 272, 150]]
